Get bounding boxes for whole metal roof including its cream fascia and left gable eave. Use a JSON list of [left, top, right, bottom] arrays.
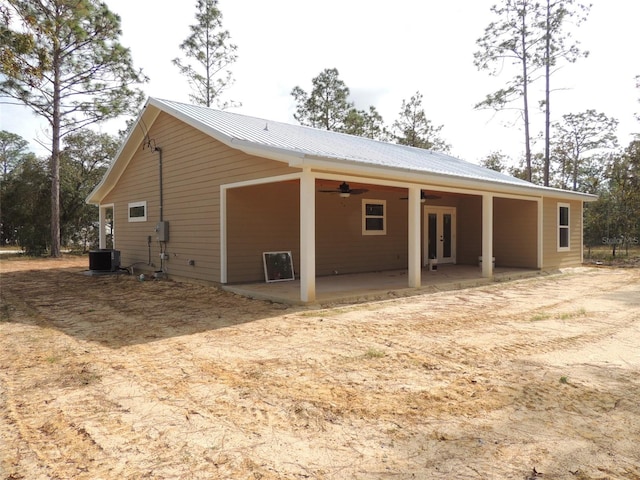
[[87, 98, 597, 205]]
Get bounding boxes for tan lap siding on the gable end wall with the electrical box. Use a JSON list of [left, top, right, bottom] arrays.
[[102, 113, 296, 282]]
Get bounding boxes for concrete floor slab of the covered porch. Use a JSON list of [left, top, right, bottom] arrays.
[[222, 264, 549, 305]]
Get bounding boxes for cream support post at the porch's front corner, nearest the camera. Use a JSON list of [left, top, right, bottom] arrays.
[[300, 171, 316, 303]]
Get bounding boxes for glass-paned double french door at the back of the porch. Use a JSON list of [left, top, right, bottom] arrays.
[[423, 206, 456, 265]]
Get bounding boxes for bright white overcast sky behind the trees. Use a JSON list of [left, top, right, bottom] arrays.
[[0, 0, 640, 165]]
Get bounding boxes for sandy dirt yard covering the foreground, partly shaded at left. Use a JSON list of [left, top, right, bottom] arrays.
[[0, 258, 640, 480]]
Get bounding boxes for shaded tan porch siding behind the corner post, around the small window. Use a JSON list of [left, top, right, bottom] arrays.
[[227, 181, 408, 283]]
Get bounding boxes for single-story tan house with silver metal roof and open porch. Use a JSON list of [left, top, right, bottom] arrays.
[[87, 98, 595, 302]]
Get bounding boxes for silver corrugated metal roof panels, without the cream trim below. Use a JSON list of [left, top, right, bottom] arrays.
[[149, 98, 535, 187]]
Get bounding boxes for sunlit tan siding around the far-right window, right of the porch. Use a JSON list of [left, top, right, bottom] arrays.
[[542, 198, 582, 269]]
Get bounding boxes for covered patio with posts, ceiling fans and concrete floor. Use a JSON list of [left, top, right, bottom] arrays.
[[220, 169, 543, 304]]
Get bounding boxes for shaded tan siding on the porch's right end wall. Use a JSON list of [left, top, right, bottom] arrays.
[[493, 198, 538, 268]]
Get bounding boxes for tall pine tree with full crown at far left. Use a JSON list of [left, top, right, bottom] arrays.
[[0, 0, 146, 257]]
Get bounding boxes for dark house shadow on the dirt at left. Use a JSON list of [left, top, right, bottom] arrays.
[[0, 268, 293, 348]]
